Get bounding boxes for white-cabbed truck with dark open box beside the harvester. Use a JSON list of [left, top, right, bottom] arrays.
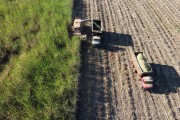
[[92, 20, 102, 47]]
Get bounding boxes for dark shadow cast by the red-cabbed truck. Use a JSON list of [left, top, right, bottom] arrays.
[[151, 64, 180, 94]]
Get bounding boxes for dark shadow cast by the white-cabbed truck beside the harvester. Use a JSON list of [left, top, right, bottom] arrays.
[[99, 31, 133, 52]]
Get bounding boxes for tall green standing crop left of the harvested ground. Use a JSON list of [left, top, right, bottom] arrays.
[[0, 0, 80, 120]]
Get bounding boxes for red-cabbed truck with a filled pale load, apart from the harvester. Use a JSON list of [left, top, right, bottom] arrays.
[[130, 49, 153, 90]]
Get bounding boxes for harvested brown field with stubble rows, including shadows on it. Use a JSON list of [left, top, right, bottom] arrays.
[[73, 0, 180, 120]]
